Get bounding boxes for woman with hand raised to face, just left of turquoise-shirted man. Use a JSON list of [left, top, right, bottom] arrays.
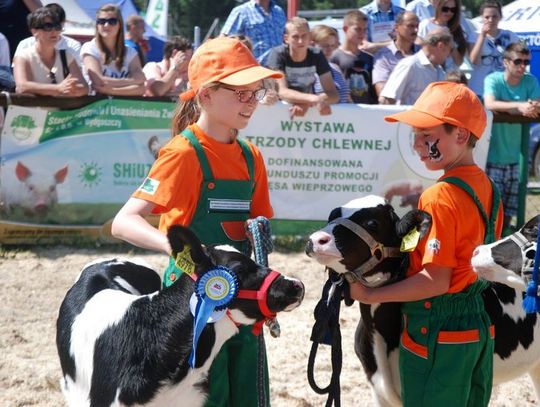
[[469, 0, 519, 96]]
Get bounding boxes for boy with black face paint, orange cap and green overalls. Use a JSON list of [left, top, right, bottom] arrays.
[[351, 82, 503, 407]]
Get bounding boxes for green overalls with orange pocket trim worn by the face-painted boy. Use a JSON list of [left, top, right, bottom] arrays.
[[399, 177, 500, 407]]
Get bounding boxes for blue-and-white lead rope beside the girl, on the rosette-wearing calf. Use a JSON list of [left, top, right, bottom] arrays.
[[248, 216, 280, 407]]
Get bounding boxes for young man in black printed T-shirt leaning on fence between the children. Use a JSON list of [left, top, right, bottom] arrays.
[[267, 17, 339, 116]]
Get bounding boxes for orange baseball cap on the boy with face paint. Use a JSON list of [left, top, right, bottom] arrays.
[[384, 82, 487, 139]]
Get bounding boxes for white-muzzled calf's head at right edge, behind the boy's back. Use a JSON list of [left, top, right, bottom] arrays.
[[471, 215, 540, 291]]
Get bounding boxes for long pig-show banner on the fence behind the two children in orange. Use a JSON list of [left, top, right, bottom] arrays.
[[0, 99, 491, 243]]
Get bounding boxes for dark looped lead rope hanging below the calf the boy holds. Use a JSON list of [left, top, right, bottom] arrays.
[[307, 271, 348, 407]]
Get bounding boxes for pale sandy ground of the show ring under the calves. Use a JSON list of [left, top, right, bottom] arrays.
[[0, 247, 538, 407]]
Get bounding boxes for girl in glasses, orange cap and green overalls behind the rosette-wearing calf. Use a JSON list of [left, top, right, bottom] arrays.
[[112, 37, 282, 406]]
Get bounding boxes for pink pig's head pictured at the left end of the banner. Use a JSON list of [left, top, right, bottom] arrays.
[[2, 161, 68, 216]]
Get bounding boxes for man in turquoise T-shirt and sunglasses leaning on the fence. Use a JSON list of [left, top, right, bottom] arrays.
[[484, 42, 540, 234]]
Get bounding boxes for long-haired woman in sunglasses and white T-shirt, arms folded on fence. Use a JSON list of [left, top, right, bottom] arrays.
[[81, 4, 145, 96]]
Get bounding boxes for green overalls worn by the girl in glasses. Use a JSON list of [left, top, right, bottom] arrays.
[[163, 129, 270, 407]]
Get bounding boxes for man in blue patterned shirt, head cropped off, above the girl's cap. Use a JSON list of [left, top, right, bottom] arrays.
[[221, 0, 287, 64]]
